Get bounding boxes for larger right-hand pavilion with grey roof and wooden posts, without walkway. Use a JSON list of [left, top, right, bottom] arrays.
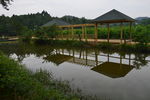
[[93, 9, 135, 44]]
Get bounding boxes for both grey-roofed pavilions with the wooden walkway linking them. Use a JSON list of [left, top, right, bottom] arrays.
[[43, 9, 135, 44]]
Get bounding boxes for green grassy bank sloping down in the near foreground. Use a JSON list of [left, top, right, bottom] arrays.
[[0, 52, 92, 100]]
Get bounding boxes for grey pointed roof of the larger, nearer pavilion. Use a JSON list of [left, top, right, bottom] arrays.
[[93, 9, 135, 23]]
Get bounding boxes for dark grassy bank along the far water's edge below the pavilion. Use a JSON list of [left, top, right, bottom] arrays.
[[34, 40, 150, 53]]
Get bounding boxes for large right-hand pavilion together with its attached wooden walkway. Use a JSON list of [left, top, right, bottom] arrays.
[[59, 9, 135, 44]]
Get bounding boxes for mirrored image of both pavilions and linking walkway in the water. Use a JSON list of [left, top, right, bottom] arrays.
[[44, 49, 149, 78]]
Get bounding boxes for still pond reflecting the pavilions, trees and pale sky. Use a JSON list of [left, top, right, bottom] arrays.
[[0, 44, 150, 100]]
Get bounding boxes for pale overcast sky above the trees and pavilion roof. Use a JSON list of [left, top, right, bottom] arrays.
[[0, 0, 150, 19]]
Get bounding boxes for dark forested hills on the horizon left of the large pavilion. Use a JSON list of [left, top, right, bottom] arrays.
[[0, 11, 89, 29]]
